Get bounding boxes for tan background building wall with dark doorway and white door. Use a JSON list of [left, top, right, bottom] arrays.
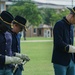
[[26, 27, 51, 37]]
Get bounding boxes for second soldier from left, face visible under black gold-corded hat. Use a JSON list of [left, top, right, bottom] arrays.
[[12, 15, 30, 75]]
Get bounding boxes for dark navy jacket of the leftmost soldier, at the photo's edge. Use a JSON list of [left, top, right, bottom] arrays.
[[0, 31, 9, 69]]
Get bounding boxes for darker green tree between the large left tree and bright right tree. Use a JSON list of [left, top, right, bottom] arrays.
[[40, 8, 55, 25]]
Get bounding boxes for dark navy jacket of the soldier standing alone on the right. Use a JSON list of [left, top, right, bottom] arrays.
[[52, 17, 73, 66]]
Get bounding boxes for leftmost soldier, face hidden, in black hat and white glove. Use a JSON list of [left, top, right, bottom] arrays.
[[0, 11, 22, 75]]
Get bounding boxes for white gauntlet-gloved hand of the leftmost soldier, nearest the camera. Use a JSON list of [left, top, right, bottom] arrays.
[[5, 56, 23, 64]]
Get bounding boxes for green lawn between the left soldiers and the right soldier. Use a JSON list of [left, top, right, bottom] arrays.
[[21, 37, 54, 75]]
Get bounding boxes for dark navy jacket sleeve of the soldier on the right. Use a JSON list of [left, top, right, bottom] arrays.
[[53, 22, 67, 51]]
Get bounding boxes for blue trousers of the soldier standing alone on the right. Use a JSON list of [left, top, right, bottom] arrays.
[[53, 60, 75, 75]]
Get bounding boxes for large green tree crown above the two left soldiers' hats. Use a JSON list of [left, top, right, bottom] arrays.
[[8, 1, 42, 25]]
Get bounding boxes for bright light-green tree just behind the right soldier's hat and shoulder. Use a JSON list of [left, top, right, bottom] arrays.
[[50, 9, 69, 25]]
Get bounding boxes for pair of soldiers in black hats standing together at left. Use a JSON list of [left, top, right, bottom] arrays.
[[0, 11, 30, 75]]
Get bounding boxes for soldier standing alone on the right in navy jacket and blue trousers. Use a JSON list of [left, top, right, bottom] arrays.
[[52, 7, 75, 75]]
